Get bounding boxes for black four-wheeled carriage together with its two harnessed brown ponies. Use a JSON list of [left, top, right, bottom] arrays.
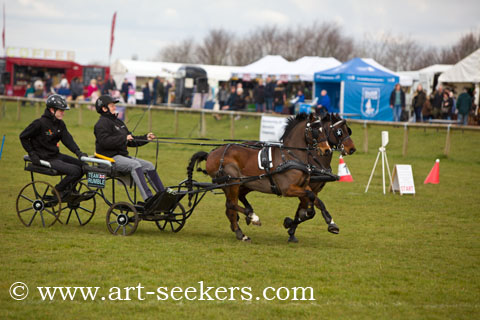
[[16, 114, 355, 241]]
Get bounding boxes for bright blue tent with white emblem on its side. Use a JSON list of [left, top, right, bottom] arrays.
[[314, 58, 399, 121]]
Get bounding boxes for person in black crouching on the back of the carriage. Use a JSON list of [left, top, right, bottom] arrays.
[[20, 94, 88, 200]]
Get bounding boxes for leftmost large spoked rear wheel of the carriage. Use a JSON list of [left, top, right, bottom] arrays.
[[17, 181, 62, 228]]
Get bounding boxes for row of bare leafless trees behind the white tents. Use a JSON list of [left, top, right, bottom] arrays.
[[155, 22, 480, 71]]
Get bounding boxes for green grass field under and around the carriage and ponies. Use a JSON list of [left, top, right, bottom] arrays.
[[0, 104, 480, 319]]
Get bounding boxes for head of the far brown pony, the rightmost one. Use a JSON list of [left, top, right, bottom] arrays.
[[322, 113, 357, 156]]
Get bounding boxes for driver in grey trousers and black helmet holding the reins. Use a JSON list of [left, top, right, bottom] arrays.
[[94, 95, 164, 202]]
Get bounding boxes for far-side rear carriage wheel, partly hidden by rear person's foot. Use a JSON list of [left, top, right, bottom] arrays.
[[64, 181, 97, 226]]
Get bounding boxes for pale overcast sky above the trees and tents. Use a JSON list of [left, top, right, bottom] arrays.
[[4, 0, 480, 64]]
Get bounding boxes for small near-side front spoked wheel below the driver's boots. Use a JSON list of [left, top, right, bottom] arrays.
[[107, 202, 139, 236]]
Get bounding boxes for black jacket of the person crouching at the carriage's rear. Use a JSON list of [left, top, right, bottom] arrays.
[[20, 109, 81, 160]]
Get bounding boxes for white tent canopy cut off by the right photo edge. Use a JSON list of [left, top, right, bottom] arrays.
[[438, 49, 480, 83]]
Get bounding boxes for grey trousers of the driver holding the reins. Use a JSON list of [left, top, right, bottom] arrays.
[[113, 155, 164, 200]]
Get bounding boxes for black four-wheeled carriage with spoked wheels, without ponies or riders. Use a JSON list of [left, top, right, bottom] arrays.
[[16, 156, 209, 236]]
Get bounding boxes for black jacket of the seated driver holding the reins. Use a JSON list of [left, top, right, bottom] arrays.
[[94, 112, 147, 158]]
